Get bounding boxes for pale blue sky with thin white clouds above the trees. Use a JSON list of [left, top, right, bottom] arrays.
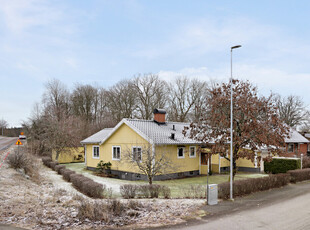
[[0, 0, 310, 127]]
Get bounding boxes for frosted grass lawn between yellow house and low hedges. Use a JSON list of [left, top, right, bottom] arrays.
[[65, 163, 267, 198]]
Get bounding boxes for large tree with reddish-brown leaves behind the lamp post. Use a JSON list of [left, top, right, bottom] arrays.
[[188, 80, 289, 179]]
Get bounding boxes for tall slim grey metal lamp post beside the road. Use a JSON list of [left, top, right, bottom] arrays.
[[230, 45, 241, 200]]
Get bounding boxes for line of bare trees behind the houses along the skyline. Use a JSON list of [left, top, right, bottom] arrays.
[[23, 74, 309, 154]]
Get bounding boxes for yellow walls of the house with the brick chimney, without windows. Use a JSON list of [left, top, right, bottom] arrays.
[[86, 124, 199, 179]]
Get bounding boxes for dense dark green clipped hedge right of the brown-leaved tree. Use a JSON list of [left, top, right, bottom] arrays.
[[264, 158, 300, 174]]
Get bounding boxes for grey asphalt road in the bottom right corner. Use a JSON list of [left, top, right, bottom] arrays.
[[161, 181, 310, 230]]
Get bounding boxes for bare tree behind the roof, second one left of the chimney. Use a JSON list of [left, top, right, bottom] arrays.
[[106, 80, 137, 122]]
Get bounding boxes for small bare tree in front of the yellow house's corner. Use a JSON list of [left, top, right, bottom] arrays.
[[122, 144, 178, 184]]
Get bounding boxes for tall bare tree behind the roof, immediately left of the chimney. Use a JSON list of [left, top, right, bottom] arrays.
[[133, 74, 167, 120]]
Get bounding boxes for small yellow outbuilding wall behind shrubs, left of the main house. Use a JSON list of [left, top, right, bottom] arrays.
[[52, 147, 84, 163]]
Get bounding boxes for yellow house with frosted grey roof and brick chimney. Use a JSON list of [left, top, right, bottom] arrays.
[[81, 109, 205, 180]]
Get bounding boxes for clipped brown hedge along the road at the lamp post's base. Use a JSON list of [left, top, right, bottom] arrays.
[[218, 173, 290, 199]]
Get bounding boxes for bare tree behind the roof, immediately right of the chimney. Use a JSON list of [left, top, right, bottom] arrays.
[[168, 76, 207, 122]]
